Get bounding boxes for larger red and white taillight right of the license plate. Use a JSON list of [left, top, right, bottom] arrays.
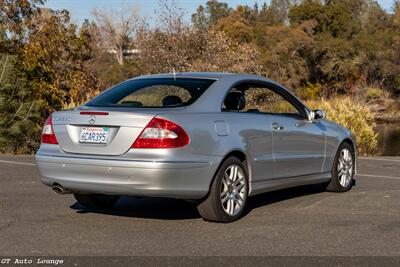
[[132, 118, 190, 148]]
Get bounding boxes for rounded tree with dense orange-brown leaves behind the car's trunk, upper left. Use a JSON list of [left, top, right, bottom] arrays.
[[16, 11, 97, 112]]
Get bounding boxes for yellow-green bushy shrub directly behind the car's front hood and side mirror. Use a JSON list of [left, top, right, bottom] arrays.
[[307, 97, 377, 155]]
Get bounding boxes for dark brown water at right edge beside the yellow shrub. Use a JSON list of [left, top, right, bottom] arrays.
[[375, 122, 400, 156]]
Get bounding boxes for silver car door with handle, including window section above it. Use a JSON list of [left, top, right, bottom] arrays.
[[260, 86, 325, 178]]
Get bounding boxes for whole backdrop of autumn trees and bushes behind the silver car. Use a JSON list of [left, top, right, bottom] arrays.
[[0, 0, 400, 154]]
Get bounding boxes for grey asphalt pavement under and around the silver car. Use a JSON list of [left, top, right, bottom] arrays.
[[0, 156, 400, 256]]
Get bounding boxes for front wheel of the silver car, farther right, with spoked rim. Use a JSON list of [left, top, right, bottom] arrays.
[[326, 143, 355, 192]]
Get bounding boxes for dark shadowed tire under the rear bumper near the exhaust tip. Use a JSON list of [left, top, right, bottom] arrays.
[[74, 193, 120, 209]]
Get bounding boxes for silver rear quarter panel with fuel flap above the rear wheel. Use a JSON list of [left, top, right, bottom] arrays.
[[159, 112, 273, 185]]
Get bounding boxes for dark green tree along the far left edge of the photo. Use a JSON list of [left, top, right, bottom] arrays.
[[0, 0, 43, 153]]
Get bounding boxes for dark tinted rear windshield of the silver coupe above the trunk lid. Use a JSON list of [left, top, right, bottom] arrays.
[[86, 78, 215, 108]]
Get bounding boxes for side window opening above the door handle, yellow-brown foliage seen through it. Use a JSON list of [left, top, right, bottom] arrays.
[[244, 86, 300, 115]]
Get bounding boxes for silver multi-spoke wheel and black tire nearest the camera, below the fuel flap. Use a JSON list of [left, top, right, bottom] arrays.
[[197, 157, 249, 223]]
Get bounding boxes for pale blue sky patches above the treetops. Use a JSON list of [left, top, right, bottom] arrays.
[[45, 0, 394, 24]]
